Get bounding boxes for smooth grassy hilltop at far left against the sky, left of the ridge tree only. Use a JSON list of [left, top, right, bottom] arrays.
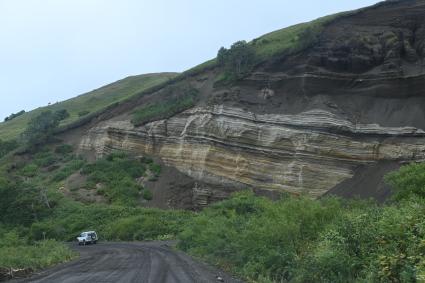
[[0, 73, 177, 140]]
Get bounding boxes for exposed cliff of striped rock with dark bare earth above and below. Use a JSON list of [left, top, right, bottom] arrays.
[[74, 0, 425, 205]]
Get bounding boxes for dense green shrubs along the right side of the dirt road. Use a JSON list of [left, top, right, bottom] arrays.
[[179, 164, 425, 282]]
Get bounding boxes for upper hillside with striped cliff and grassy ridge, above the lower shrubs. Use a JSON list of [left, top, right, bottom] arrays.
[[0, 0, 425, 204]]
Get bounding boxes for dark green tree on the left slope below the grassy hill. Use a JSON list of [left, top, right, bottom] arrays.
[[22, 110, 69, 147]]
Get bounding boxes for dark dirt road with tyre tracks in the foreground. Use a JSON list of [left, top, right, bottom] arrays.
[[17, 242, 241, 283]]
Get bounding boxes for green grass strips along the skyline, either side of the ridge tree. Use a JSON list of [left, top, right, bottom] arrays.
[[0, 4, 372, 140]]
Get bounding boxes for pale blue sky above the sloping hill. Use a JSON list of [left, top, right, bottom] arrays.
[[0, 0, 379, 121]]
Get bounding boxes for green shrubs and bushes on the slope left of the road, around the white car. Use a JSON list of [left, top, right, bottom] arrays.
[[0, 110, 193, 278]]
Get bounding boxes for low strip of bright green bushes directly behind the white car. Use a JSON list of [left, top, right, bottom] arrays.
[[29, 201, 192, 241]]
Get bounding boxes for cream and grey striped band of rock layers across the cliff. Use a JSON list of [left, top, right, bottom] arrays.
[[80, 105, 425, 196]]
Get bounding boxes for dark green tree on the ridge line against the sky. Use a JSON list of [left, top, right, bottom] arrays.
[[217, 40, 255, 79]]
